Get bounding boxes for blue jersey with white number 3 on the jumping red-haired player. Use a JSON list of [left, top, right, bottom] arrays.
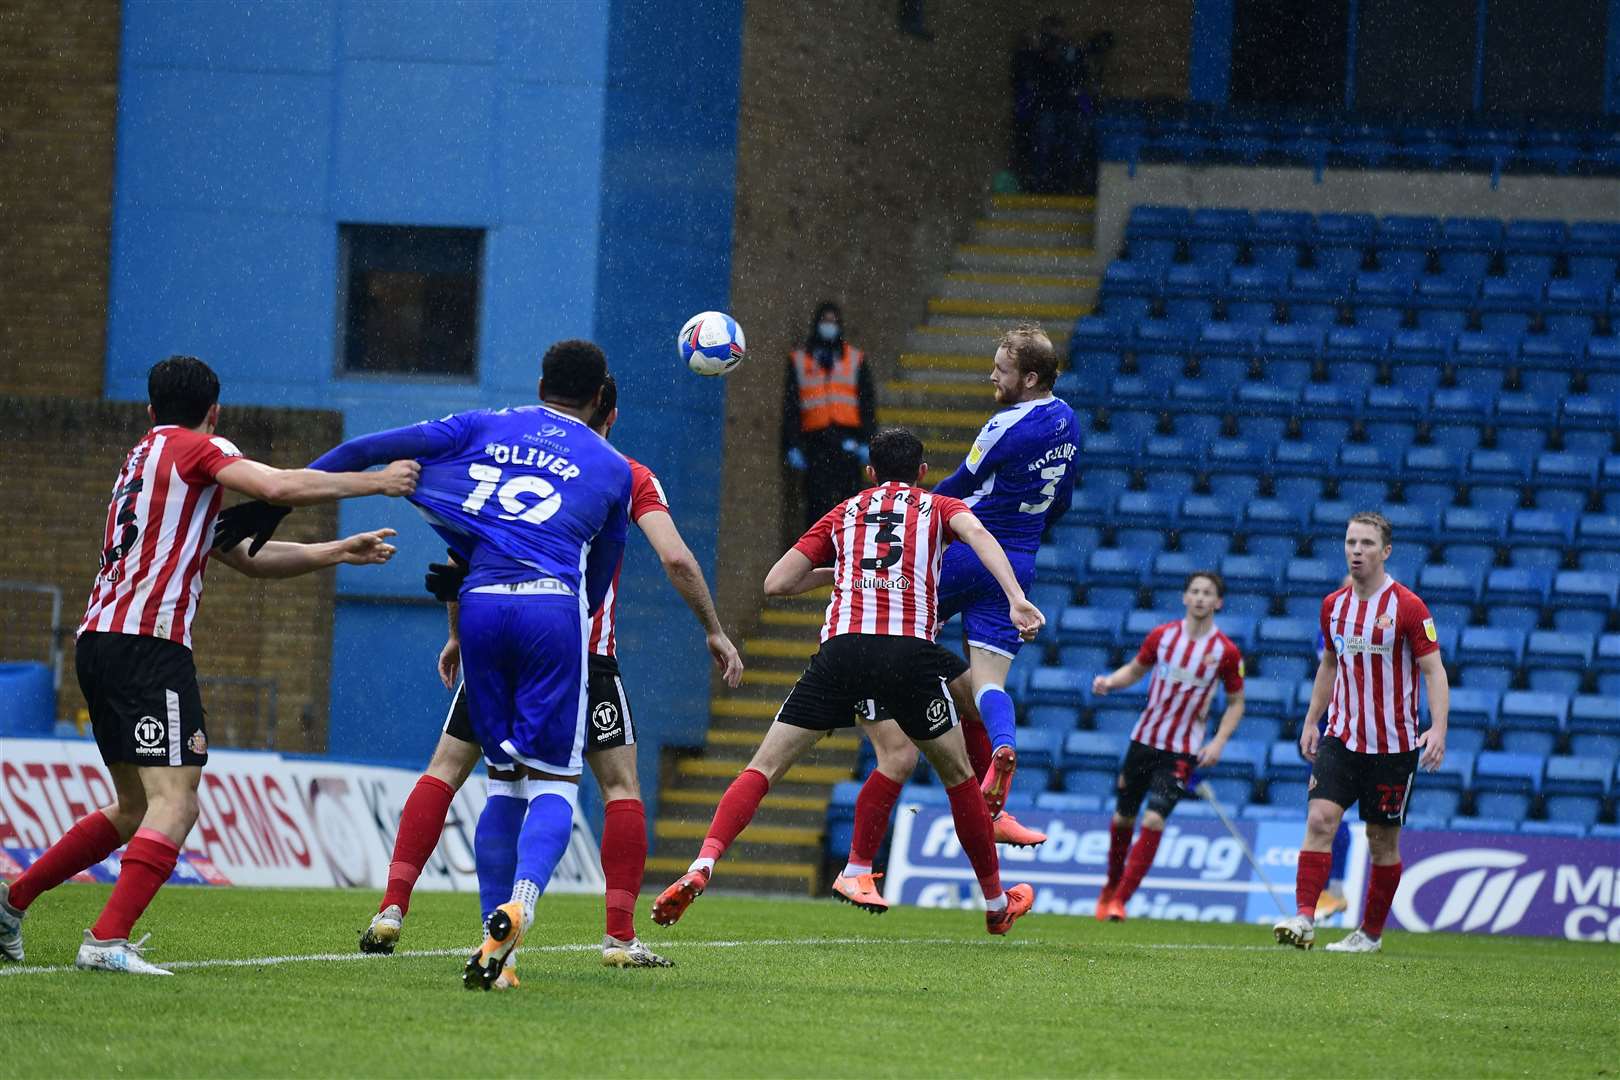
[[935, 397, 1079, 552]]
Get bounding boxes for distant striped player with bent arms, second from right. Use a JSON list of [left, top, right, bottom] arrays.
[[1092, 570, 1244, 923]]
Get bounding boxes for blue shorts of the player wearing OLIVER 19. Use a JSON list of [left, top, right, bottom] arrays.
[[460, 593, 586, 776]]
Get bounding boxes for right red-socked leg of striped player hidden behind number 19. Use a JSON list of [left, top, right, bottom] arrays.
[[585, 743, 674, 968]]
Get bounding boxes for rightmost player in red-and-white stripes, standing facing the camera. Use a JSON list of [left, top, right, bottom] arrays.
[[1272, 512, 1452, 952]]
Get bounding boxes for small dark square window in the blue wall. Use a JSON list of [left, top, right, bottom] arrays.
[[337, 225, 484, 379]]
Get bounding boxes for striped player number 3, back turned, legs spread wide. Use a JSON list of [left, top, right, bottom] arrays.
[[653, 429, 1045, 934]]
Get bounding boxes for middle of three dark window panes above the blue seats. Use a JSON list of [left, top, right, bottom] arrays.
[[1354, 0, 1479, 113]]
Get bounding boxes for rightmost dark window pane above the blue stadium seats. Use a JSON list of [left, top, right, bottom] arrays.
[[1484, 0, 1609, 113]]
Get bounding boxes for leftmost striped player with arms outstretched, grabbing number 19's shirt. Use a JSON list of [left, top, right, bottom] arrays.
[[0, 356, 420, 975]]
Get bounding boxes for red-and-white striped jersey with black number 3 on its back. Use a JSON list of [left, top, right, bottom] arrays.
[[794, 481, 970, 641]]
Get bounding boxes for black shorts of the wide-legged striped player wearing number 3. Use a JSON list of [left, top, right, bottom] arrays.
[[776, 633, 967, 740]]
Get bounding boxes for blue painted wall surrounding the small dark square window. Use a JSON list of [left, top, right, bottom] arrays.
[[107, 0, 742, 822]]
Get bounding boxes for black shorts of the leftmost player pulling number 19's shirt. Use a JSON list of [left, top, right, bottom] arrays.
[[75, 630, 207, 766]]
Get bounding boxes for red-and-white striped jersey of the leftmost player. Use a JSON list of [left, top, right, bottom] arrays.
[[79, 424, 241, 648]]
